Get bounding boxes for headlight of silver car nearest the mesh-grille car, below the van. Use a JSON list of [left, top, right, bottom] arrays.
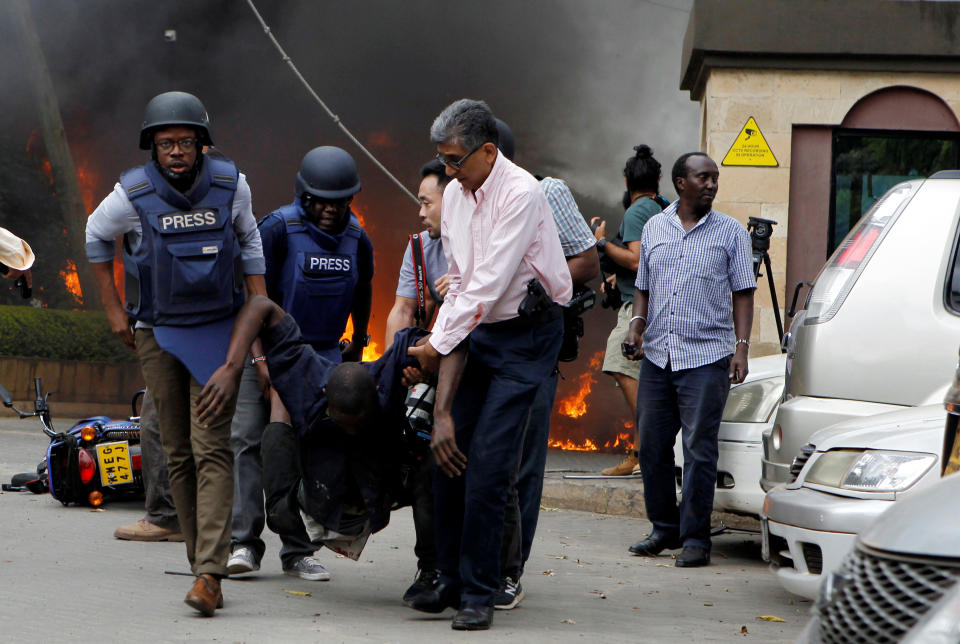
[[804, 449, 937, 492]]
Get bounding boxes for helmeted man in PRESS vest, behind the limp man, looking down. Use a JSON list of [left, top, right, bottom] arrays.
[[227, 146, 373, 581]]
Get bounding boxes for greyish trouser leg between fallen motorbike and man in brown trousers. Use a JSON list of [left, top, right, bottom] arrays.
[[140, 391, 180, 532]]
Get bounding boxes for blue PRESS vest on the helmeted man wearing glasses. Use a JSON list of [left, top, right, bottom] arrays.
[[120, 156, 244, 326]]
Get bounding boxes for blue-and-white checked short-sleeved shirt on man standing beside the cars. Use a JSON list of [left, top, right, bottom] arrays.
[[636, 202, 757, 371]]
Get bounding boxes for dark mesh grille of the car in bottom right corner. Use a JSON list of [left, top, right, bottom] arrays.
[[819, 548, 960, 644]]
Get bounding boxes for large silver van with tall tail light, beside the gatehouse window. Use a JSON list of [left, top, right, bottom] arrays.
[[761, 171, 960, 490]]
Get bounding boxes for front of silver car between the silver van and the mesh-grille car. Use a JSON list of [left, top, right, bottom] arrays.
[[761, 404, 946, 599]]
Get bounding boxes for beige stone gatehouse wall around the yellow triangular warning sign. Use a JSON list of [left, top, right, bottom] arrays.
[[700, 68, 960, 356]]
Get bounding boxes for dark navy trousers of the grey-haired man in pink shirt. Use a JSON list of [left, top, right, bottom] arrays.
[[433, 310, 562, 606]]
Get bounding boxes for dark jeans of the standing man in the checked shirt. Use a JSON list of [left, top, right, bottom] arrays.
[[637, 357, 730, 550]]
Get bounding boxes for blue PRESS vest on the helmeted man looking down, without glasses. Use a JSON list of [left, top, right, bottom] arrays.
[[270, 202, 363, 346]]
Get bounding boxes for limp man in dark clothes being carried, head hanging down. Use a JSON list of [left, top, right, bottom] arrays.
[[198, 297, 427, 559]]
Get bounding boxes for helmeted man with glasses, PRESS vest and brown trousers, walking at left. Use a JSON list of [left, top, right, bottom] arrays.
[[86, 92, 266, 617]]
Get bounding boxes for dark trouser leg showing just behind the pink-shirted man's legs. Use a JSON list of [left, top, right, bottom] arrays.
[[500, 370, 557, 580]]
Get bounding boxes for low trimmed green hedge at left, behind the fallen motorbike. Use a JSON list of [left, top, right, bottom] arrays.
[[0, 306, 136, 362]]
